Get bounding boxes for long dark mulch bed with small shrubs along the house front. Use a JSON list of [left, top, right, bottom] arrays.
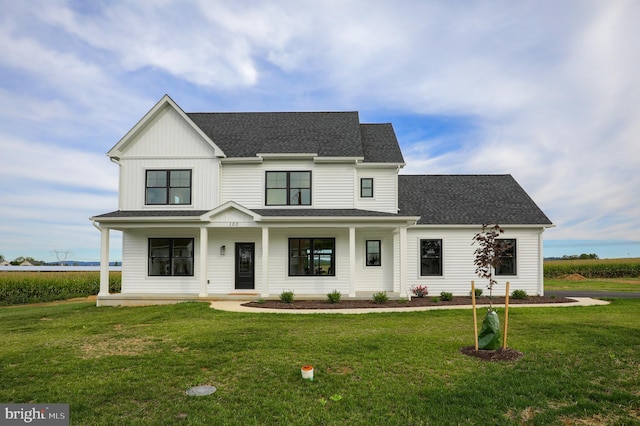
[[242, 296, 575, 309]]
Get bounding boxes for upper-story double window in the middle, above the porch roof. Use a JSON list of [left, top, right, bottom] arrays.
[[265, 172, 311, 206]]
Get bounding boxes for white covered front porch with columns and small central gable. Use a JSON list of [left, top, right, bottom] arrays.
[[91, 203, 420, 306]]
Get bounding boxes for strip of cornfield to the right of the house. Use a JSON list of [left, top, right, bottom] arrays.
[[544, 258, 640, 278]]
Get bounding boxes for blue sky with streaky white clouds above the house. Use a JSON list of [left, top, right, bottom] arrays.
[[0, 0, 640, 260]]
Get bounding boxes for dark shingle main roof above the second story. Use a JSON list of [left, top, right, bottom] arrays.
[[187, 112, 403, 162]]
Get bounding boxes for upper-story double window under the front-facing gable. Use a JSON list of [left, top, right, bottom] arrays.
[[145, 170, 191, 205]]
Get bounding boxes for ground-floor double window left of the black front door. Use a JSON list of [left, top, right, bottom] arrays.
[[149, 238, 193, 276]]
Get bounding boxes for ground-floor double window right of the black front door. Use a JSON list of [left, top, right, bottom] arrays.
[[289, 238, 336, 276]]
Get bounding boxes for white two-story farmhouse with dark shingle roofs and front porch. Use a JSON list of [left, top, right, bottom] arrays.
[[91, 96, 553, 305]]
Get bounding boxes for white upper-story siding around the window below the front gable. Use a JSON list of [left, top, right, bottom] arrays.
[[120, 158, 219, 210]]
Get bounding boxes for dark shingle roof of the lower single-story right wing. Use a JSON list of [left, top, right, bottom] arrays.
[[398, 175, 552, 225]]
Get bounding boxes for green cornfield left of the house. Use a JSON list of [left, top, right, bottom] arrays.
[[0, 271, 122, 306]]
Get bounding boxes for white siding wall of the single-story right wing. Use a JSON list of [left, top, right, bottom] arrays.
[[404, 227, 543, 296]]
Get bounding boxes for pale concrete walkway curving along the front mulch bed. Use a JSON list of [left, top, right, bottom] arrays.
[[210, 297, 609, 314]]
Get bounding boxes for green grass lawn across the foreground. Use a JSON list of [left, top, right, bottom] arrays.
[[0, 299, 640, 425]]
